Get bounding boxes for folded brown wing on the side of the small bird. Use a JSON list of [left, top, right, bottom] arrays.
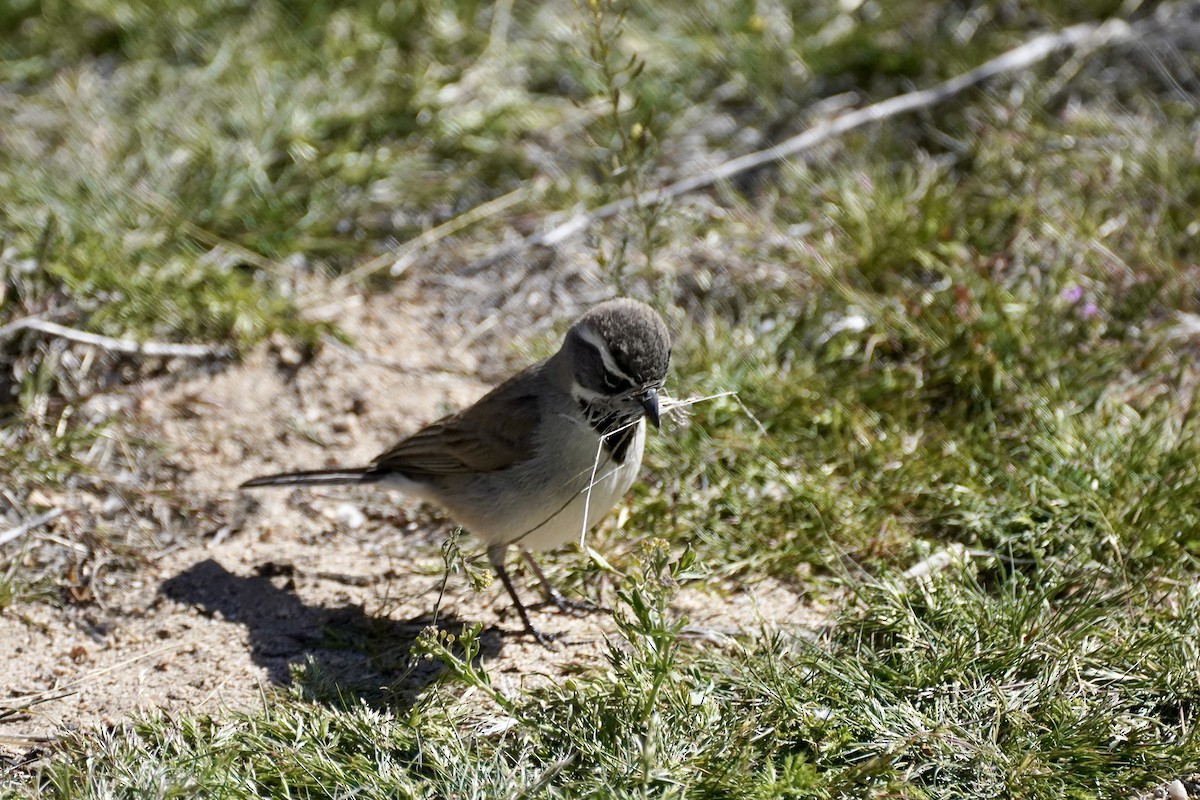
[[371, 367, 540, 477]]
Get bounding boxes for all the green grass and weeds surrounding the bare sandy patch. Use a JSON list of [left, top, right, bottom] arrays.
[[0, 0, 1200, 799]]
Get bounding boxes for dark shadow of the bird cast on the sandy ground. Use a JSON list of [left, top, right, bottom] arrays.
[[160, 559, 502, 710]]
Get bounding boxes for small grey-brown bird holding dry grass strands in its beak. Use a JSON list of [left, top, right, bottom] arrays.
[[241, 297, 672, 642]]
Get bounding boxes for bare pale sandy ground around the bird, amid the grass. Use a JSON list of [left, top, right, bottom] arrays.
[[0, 284, 821, 757]]
